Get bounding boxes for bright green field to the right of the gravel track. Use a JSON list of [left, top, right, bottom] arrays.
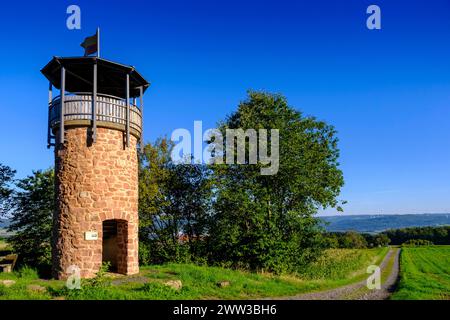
[[392, 246, 450, 300]]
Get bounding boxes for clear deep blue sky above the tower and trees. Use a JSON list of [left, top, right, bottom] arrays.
[[0, 0, 450, 214]]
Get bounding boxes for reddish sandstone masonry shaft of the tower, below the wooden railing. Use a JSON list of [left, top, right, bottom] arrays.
[[52, 127, 139, 279]]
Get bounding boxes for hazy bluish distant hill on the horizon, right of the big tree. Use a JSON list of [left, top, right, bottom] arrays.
[[321, 213, 450, 233]]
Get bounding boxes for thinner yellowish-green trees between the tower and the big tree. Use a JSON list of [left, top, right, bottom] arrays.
[[139, 138, 210, 264]]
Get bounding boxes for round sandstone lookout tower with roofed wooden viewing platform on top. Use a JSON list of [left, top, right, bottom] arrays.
[[41, 57, 149, 279]]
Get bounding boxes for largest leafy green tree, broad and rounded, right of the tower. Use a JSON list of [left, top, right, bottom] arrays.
[[209, 91, 343, 272]]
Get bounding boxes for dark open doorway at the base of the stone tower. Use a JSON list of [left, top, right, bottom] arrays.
[[102, 219, 128, 273]]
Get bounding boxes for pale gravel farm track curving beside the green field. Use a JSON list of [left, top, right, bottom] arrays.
[[274, 249, 400, 300]]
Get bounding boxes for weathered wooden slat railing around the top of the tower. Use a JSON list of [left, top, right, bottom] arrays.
[[49, 93, 142, 138]]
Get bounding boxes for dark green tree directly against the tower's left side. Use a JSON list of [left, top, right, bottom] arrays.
[[8, 169, 55, 271]]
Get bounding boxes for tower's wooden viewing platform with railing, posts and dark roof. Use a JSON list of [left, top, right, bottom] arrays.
[[41, 57, 150, 147]]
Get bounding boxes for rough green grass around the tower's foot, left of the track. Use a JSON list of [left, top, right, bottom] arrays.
[[0, 248, 387, 300]]
